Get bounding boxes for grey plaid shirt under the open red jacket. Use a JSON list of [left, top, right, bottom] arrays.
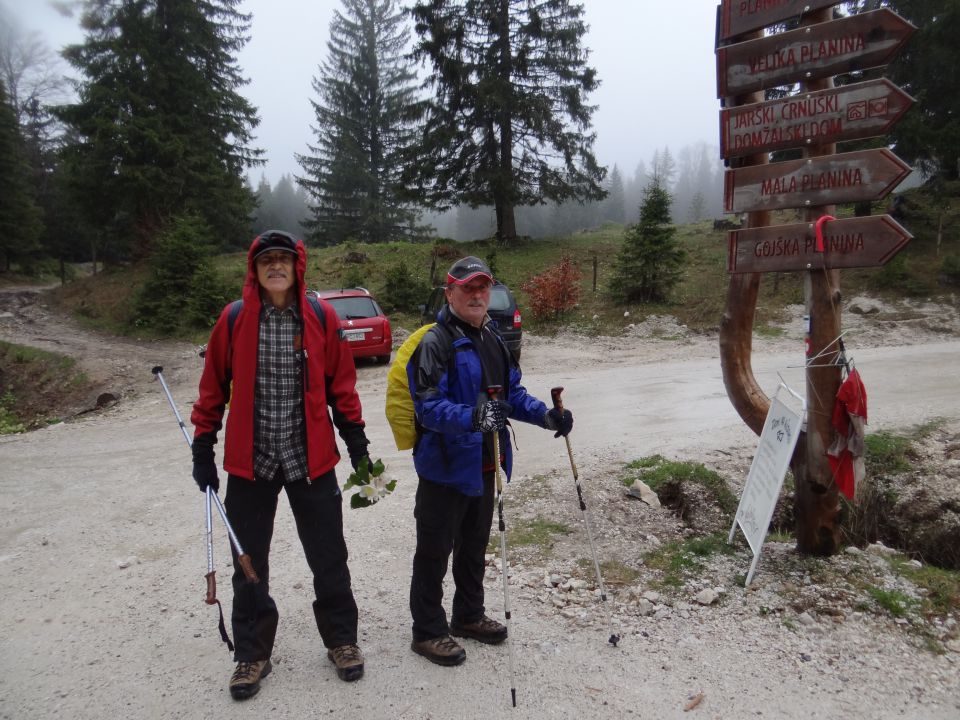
[[253, 299, 310, 482]]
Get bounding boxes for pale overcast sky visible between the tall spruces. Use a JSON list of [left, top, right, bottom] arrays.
[[11, 0, 719, 185]]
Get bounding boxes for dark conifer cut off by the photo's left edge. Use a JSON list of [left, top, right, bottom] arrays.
[[0, 79, 43, 271]]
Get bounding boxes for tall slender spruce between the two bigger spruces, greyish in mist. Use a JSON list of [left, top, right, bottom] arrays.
[[297, 0, 420, 245]]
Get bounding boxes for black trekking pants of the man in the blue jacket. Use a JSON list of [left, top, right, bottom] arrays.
[[410, 471, 494, 642]]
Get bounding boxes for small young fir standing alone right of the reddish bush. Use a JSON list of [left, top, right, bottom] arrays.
[[610, 179, 686, 302]]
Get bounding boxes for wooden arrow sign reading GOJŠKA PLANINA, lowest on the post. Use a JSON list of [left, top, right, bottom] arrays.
[[727, 215, 913, 273]]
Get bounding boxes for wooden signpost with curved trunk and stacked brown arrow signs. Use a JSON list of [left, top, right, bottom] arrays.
[[716, 0, 915, 572]]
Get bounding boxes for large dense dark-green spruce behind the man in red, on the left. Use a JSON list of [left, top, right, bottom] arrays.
[[58, 0, 261, 254]]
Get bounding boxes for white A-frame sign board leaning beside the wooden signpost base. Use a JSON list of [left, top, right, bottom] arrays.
[[727, 385, 806, 585]]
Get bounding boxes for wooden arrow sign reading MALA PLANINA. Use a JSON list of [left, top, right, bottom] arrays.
[[723, 148, 910, 213]]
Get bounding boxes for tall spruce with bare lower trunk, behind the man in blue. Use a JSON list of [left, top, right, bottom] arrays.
[[408, 0, 605, 243]]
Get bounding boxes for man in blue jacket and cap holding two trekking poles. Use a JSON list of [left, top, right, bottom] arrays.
[[407, 257, 573, 665]]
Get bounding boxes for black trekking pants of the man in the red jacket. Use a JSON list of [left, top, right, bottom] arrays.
[[224, 470, 357, 662]]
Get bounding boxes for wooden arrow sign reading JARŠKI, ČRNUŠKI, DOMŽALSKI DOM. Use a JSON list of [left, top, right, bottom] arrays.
[[720, 78, 913, 158]]
